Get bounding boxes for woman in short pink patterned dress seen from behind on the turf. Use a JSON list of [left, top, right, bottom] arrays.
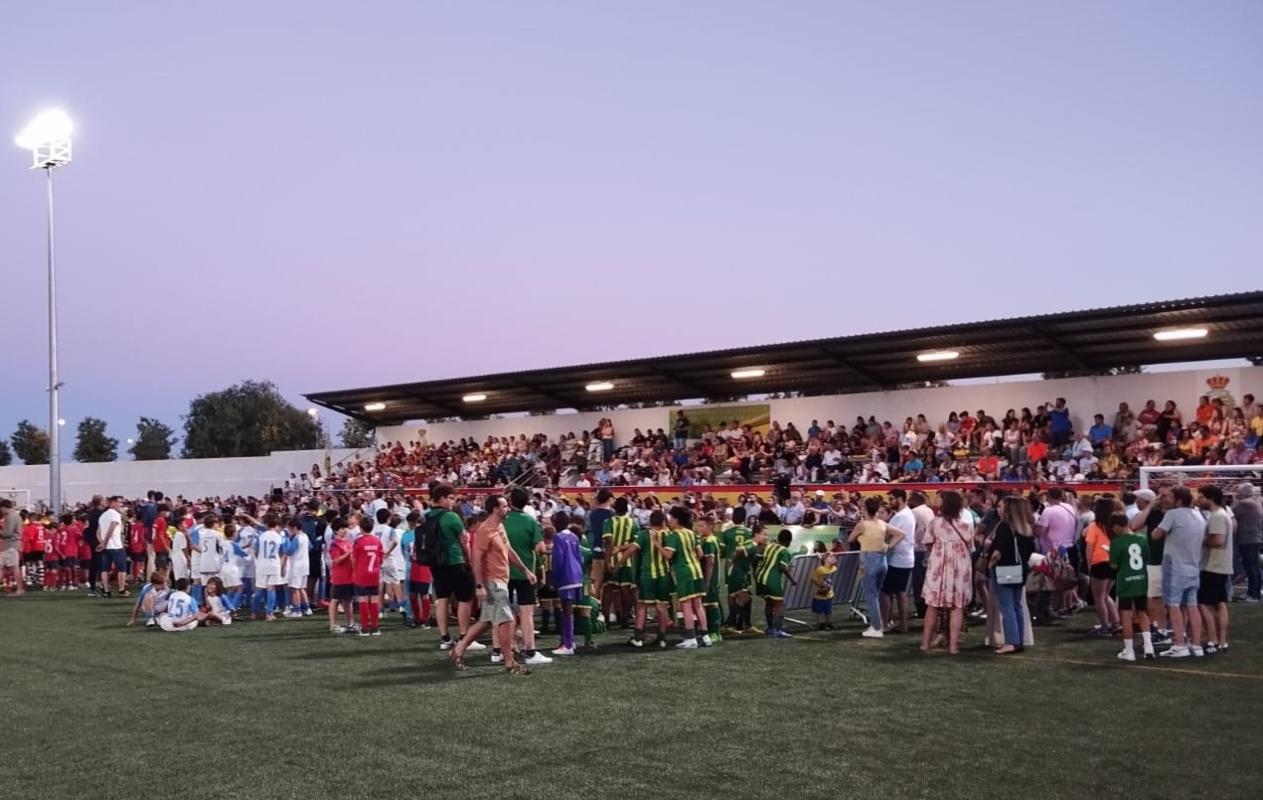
[[921, 492, 974, 655]]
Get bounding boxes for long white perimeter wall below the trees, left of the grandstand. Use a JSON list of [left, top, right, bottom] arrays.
[[0, 450, 355, 503]]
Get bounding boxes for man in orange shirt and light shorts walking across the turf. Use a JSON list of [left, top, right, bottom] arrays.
[[451, 494, 538, 675]]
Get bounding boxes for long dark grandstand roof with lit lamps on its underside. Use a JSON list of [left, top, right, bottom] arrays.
[[307, 291, 1263, 425]]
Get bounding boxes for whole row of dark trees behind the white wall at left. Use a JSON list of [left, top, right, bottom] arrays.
[[0, 380, 373, 466]]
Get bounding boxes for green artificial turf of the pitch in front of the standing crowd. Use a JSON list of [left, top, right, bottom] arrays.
[[0, 593, 1263, 800]]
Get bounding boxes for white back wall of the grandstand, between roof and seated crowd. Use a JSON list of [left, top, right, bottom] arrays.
[[378, 367, 1263, 444]]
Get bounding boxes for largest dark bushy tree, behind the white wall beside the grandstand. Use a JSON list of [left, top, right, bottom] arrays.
[[184, 380, 320, 459]]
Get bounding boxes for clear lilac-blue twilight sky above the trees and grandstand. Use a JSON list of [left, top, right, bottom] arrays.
[[0, 0, 1263, 454]]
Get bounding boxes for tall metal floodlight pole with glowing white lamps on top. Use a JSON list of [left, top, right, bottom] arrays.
[[16, 111, 73, 514]]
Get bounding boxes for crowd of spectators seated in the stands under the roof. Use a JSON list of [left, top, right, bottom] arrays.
[[301, 394, 1263, 489]]
